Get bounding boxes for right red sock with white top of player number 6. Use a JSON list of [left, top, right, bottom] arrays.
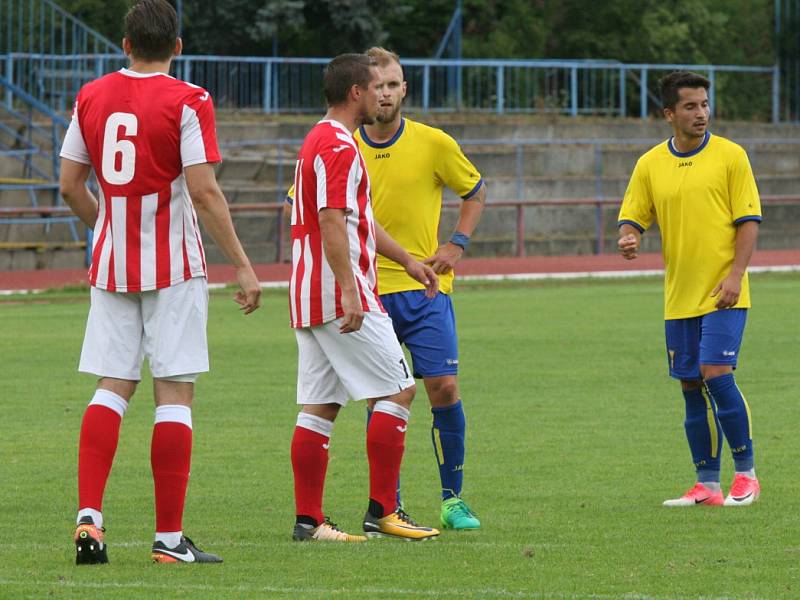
[[150, 405, 192, 532]]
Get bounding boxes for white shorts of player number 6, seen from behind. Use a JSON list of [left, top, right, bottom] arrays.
[[78, 277, 208, 381]]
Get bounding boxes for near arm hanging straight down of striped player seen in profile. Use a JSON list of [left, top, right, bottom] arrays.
[[319, 208, 364, 333]]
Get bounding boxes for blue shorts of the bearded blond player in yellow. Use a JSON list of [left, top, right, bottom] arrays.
[[381, 290, 458, 379]]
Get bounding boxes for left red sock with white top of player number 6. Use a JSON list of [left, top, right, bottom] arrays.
[[78, 390, 127, 511]]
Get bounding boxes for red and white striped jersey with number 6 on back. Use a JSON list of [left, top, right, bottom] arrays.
[[61, 69, 220, 292]]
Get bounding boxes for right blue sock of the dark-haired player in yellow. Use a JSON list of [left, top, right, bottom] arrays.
[[706, 373, 753, 473]]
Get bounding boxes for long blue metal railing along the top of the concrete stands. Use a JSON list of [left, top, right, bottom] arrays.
[[0, 52, 782, 122]]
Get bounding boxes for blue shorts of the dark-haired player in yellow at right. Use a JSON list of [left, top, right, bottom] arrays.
[[664, 308, 747, 381]]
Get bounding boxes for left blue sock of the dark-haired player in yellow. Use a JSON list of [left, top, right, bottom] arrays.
[[683, 387, 722, 485]]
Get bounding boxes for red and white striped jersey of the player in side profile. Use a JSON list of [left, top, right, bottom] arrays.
[[289, 120, 385, 327]]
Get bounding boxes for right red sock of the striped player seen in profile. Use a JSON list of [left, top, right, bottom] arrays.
[[367, 401, 408, 517]]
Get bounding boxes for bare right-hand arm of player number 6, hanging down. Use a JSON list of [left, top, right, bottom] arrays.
[[184, 163, 261, 315]]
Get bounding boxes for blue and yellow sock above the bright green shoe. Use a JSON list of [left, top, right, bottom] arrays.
[[431, 400, 467, 500]]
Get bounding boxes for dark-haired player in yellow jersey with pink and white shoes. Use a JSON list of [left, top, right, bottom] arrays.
[[618, 71, 761, 506]]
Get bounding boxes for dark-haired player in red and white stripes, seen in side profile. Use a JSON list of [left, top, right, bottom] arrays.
[[289, 54, 439, 542]]
